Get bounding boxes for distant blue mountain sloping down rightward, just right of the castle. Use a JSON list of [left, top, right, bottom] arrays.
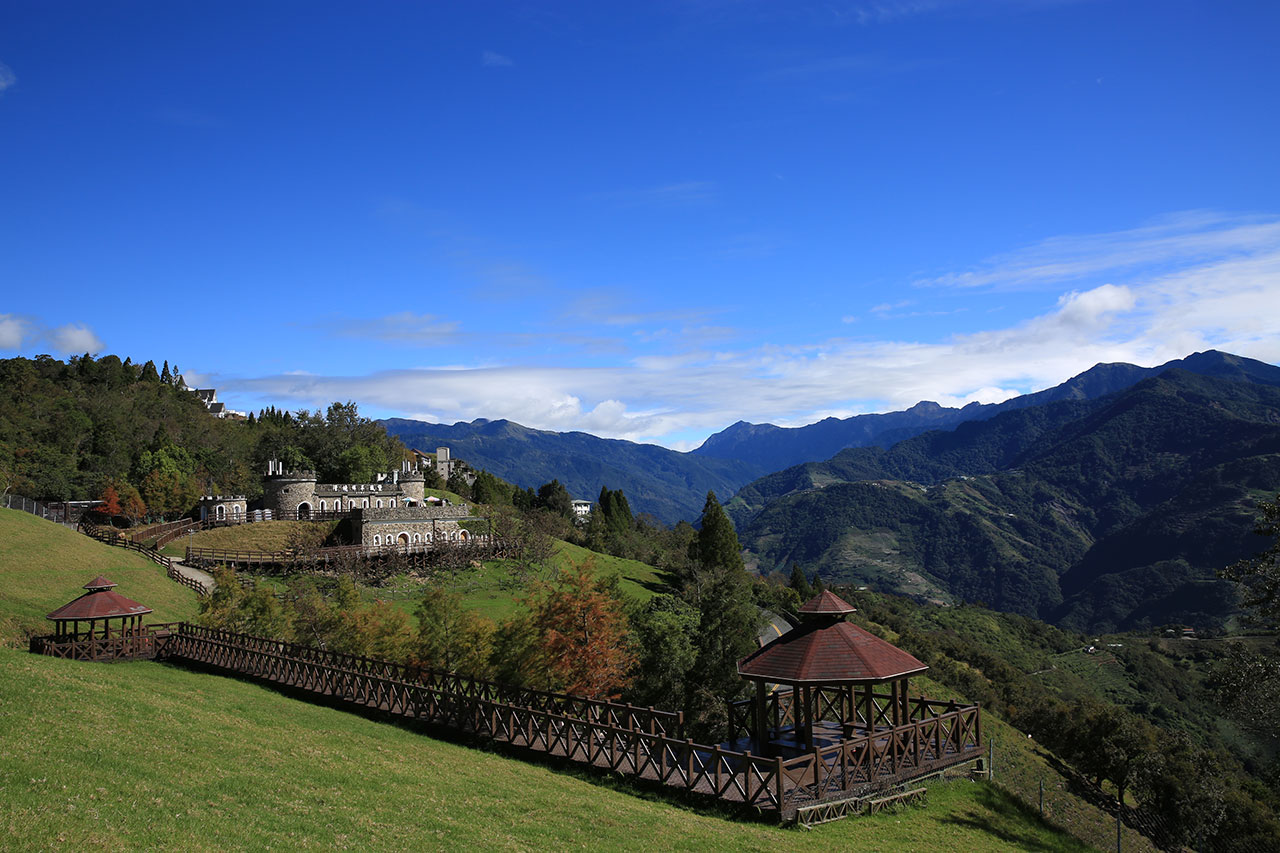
[[379, 418, 757, 524]]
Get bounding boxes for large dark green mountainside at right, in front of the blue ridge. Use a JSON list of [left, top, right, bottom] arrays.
[[727, 370, 1280, 630]]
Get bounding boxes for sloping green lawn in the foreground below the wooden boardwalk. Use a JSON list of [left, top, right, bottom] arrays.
[[0, 649, 1088, 852]]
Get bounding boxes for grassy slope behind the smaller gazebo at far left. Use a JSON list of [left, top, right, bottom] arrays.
[[0, 510, 196, 646]]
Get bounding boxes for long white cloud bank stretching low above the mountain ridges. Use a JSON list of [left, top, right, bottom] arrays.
[[224, 215, 1280, 446]]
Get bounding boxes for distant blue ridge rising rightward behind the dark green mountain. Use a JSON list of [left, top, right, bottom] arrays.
[[691, 350, 1280, 471]]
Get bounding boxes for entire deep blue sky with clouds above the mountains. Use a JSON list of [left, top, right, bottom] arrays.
[[0, 0, 1280, 448]]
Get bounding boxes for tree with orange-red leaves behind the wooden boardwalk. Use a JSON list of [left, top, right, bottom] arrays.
[[530, 560, 636, 699]]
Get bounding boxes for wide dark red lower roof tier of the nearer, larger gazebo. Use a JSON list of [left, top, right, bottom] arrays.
[[737, 614, 928, 684]]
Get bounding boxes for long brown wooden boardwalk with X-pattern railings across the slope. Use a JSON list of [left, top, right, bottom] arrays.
[[145, 624, 980, 820]]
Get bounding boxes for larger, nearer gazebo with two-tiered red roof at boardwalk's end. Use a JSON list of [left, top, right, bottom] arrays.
[[737, 590, 928, 753]]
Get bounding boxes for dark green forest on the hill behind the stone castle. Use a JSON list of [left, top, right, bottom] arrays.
[[0, 355, 404, 517]]
